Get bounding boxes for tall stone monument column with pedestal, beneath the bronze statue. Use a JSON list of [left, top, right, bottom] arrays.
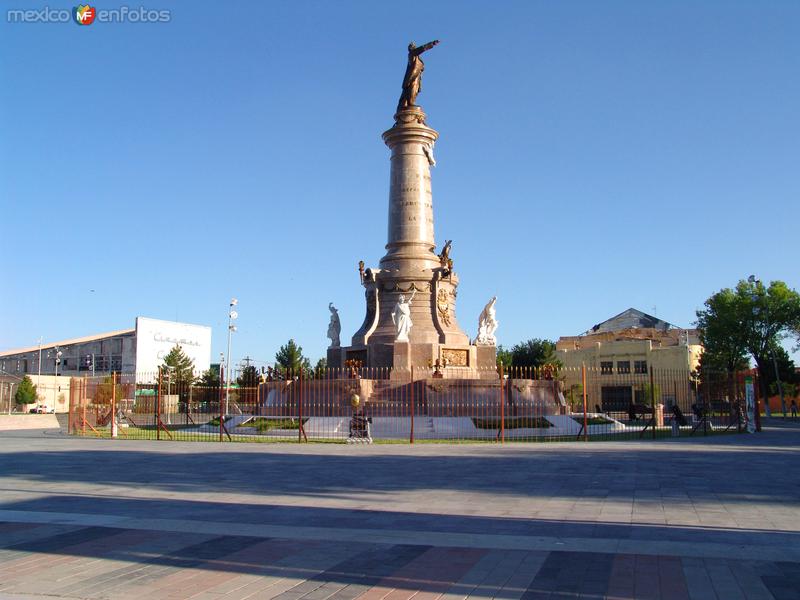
[[344, 106, 477, 371]]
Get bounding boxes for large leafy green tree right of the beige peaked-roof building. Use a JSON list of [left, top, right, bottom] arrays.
[[697, 280, 800, 404]]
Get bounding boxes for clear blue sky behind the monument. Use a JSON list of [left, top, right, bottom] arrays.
[[0, 0, 800, 370]]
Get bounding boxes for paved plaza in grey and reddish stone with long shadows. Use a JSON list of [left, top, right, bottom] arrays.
[[0, 427, 800, 600]]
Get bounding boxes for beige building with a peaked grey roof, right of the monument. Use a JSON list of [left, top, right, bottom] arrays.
[[556, 308, 703, 412]]
